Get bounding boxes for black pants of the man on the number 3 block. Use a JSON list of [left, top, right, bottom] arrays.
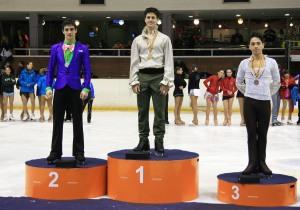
[[244, 97, 271, 166]]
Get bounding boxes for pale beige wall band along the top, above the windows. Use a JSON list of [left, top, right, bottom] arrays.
[[0, 0, 300, 12]]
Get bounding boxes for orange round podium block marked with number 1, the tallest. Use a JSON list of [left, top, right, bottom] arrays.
[[107, 150, 199, 203]]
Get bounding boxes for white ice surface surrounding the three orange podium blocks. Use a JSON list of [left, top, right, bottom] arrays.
[[0, 111, 300, 206]]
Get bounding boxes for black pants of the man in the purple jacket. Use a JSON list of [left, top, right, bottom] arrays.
[[51, 86, 84, 156]]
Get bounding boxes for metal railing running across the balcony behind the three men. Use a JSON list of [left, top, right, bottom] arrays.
[[14, 47, 285, 57]]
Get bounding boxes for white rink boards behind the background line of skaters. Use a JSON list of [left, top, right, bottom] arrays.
[[14, 79, 238, 109]]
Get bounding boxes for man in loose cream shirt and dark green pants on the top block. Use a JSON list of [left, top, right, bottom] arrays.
[[130, 7, 174, 157]]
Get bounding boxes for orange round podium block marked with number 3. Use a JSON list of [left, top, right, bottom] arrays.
[[218, 172, 297, 207]]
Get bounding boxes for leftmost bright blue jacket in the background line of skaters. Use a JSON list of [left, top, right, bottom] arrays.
[[19, 68, 37, 93]]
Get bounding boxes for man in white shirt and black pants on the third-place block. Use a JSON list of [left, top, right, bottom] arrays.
[[236, 34, 280, 176]]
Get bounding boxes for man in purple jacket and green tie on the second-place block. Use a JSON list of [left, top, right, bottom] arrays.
[[46, 19, 91, 165]]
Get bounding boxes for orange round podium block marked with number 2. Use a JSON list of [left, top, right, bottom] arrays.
[[25, 158, 107, 200]]
